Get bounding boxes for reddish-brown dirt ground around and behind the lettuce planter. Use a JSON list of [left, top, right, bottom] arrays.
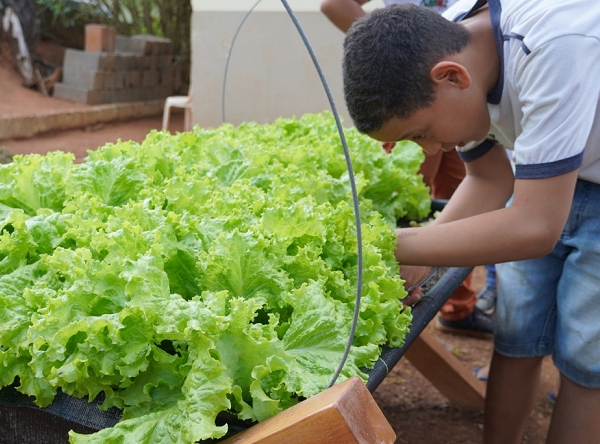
[[0, 39, 557, 444]]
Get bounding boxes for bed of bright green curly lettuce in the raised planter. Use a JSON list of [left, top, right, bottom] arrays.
[[0, 113, 429, 444]]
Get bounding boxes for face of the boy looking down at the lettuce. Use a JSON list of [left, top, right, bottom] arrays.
[[369, 80, 490, 154]]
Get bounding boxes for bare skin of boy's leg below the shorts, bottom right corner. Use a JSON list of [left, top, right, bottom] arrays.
[[547, 375, 600, 444]]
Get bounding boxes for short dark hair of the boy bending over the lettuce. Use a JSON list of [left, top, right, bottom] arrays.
[[343, 4, 470, 134]]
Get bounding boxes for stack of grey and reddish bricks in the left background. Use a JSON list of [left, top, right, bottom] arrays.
[[54, 29, 181, 105]]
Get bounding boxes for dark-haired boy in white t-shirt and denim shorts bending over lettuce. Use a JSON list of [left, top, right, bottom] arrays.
[[343, 0, 600, 444]]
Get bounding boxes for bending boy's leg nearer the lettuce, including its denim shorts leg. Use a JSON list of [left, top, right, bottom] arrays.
[[492, 255, 563, 444]]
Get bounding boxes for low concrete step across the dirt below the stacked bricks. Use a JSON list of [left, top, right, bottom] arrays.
[[0, 99, 165, 140]]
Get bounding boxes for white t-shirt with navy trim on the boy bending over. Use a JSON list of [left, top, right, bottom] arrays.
[[444, 0, 600, 183]]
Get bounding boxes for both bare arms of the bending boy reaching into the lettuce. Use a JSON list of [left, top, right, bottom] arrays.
[[396, 145, 577, 266]]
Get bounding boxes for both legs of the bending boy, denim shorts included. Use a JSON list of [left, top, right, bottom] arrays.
[[492, 180, 600, 443]]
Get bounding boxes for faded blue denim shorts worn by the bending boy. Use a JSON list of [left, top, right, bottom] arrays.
[[494, 180, 600, 388]]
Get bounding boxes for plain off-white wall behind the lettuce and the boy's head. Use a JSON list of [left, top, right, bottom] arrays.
[[191, 0, 380, 127]]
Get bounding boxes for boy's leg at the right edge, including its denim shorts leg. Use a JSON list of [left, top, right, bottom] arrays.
[[548, 181, 600, 444]]
